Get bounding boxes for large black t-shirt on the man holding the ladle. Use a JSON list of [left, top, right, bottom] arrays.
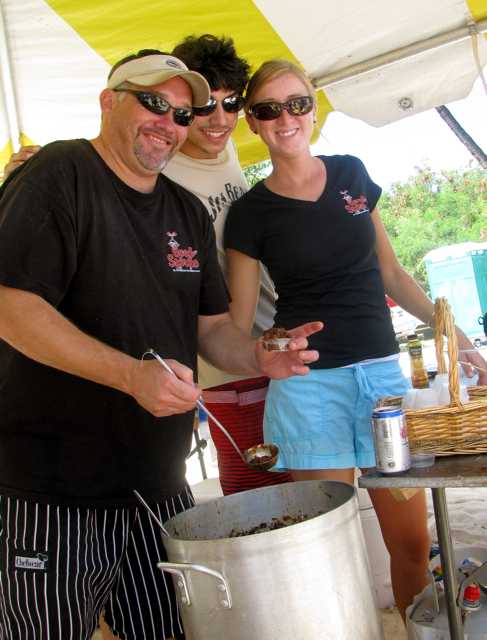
[[0, 140, 228, 508]]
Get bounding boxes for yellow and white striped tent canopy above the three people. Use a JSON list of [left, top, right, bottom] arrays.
[[0, 0, 487, 170]]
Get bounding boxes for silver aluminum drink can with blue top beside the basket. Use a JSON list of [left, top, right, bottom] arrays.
[[372, 407, 411, 475]]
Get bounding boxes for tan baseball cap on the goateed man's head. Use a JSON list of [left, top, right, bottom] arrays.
[[107, 53, 211, 107]]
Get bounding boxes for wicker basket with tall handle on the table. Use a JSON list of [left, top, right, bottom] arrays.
[[376, 298, 487, 456]]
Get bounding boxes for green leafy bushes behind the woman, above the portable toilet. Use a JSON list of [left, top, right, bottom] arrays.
[[379, 163, 487, 293]]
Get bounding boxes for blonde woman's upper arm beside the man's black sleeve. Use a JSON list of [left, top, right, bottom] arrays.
[[227, 249, 260, 335]]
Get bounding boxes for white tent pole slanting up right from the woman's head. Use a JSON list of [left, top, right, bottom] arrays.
[[313, 20, 487, 89]]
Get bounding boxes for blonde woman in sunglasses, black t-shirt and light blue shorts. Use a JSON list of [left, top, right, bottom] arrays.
[[225, 60, 485, 619]]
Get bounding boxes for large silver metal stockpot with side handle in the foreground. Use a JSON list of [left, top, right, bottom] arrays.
[[158, 480, 384, 640]]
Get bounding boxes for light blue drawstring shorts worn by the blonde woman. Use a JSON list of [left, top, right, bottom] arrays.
[[264, 360, 408, 471]]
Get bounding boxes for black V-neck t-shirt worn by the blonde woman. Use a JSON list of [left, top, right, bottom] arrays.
[[225, 156, 398, 369]]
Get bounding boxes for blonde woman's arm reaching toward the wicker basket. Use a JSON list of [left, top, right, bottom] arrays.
[[372, 207, 487, 385]]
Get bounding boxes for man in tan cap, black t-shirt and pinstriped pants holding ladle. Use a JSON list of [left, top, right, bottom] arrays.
[[0, 52, 320, 640]]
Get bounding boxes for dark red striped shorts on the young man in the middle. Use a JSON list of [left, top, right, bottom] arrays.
[[203, 377, 292, 495]]
